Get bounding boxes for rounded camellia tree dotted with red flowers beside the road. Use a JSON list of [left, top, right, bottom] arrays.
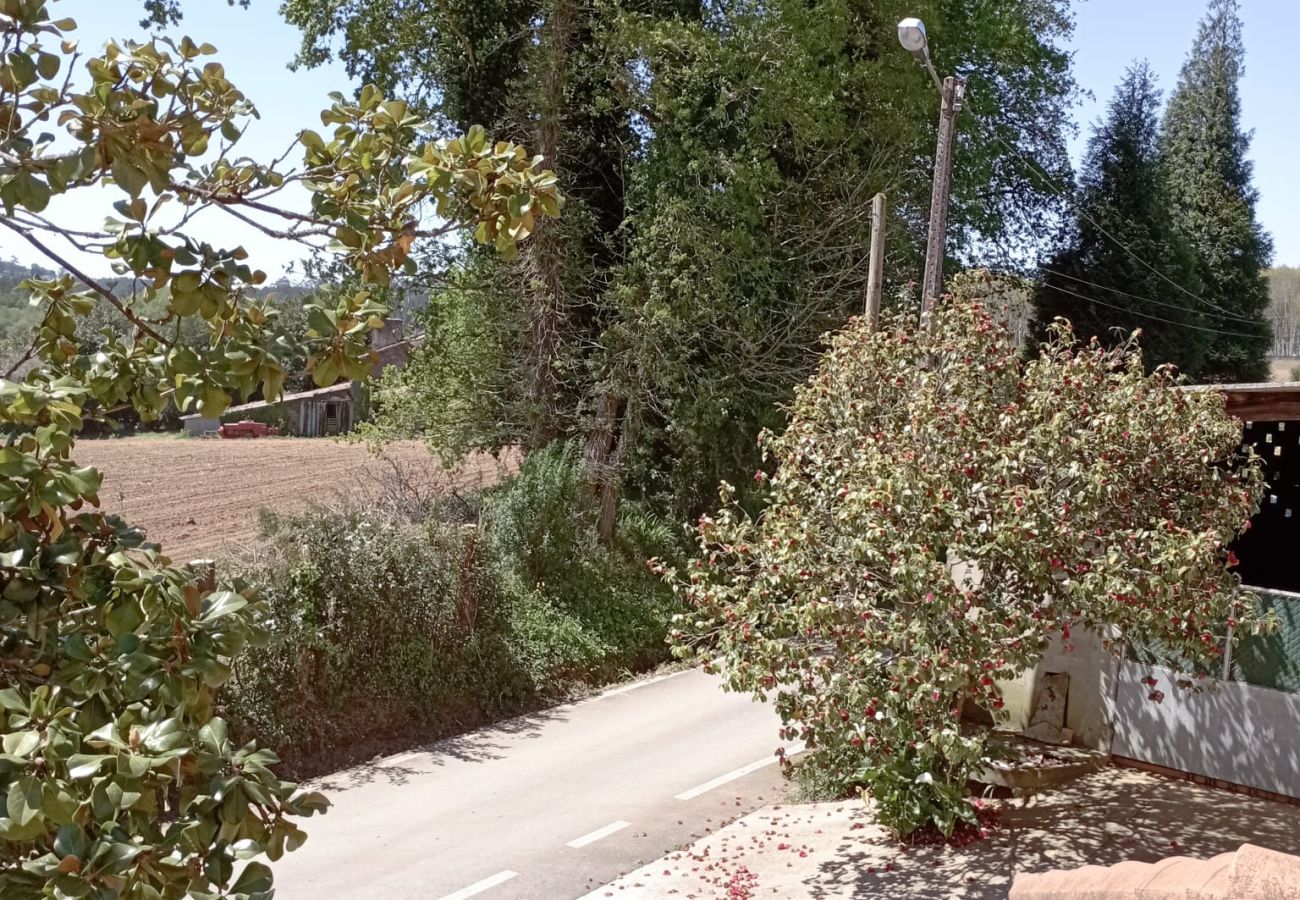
[[668, 288, 1261, 835]]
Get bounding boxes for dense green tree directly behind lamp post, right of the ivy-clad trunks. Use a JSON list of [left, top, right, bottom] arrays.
[[602, 0, 1073, 515]]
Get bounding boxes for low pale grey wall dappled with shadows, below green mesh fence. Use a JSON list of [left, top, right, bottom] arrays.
[[1112, 662, 1300, 797]]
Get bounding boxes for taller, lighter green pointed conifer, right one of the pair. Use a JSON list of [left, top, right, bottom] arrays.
[[1161, 0, 1273, 381]]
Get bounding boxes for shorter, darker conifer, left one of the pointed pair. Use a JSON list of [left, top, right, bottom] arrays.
[[1035, 62, 1206, 376]]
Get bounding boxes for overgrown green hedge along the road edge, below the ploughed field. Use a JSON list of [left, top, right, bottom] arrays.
[[226, 446, 677, 773]]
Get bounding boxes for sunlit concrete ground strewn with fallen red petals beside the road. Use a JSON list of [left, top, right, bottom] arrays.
[[584, 769, 1300, 900]]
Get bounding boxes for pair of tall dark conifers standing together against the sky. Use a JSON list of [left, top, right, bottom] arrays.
[[1036, 0, 1273, 382]]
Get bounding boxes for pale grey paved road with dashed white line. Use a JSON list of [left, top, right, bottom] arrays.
[[276, 670, 781, 900]]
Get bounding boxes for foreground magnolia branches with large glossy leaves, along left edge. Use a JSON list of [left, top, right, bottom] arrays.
[[0, 0, 560, 900]]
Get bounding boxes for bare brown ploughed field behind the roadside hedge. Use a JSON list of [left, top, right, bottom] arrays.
[[74, 436, 502, 562]]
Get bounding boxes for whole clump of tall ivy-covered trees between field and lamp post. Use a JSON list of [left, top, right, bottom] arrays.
[[292, 0, 1074, 530]]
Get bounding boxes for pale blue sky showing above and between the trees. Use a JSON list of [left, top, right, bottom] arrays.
[[0, 0, 1300, 278]]
